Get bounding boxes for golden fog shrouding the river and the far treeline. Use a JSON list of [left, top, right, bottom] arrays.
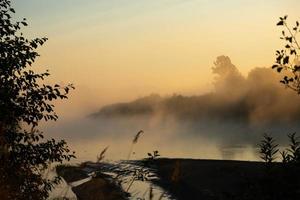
[[44, 56, 300, 160]]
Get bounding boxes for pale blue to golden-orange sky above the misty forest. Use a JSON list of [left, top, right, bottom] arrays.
[[13, 0, 300, 119]]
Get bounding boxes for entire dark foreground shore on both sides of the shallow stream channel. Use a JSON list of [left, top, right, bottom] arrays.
[[57, 158, 300, 200]]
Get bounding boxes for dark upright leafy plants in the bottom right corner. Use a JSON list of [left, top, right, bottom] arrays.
[[253, 133, 300, 199]]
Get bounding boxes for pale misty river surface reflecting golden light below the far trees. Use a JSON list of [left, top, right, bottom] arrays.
[[44, 118, 263, 163]]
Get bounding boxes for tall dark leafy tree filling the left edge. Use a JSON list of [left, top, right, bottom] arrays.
[[0, 0, 74, 199]]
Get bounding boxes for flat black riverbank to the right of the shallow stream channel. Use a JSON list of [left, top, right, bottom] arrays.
[[145, 158, 300, 200]]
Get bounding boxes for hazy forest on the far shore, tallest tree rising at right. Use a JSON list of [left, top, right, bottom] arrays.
[[92, 56, 300, 124]]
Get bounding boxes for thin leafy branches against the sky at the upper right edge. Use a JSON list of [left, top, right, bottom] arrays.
[[272, 16, 300, 94]]
